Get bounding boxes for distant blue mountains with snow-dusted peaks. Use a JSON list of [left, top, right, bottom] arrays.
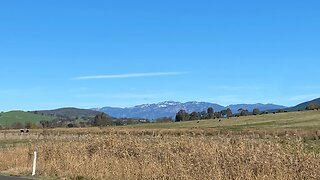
[[93, 101, 286, 120]]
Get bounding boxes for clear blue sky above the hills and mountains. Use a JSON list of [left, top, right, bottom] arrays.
[[0, 0, 320, 111]]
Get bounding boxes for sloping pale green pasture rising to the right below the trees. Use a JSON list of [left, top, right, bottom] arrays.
[[126, 111, 320, 130]]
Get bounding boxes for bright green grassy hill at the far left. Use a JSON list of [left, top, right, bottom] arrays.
[[0, 111, 53, 127]]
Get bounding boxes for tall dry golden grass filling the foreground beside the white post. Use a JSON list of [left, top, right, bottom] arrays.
[[0, 129, 320, 179]]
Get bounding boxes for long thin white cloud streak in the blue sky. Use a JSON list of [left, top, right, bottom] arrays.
[[72, 72, 186, 80]]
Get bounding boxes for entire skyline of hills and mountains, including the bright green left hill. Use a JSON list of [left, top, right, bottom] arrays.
[[0, 98, 320, 127]]
